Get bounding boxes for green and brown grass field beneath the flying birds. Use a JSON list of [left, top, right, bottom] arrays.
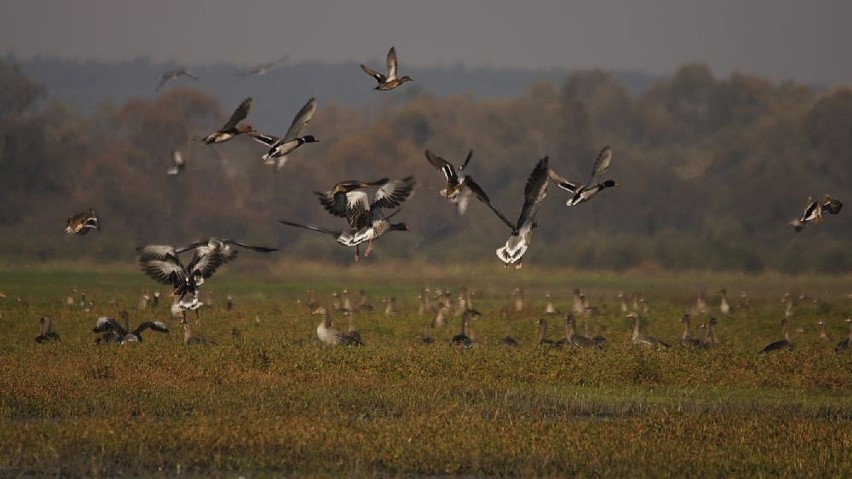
[[0, 259, 852, 477]]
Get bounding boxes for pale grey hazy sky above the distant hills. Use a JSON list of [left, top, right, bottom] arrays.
[[0, 0, 852, 85]]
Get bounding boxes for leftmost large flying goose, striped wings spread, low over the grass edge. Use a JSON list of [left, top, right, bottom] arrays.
[[137, 237, 277, 310]]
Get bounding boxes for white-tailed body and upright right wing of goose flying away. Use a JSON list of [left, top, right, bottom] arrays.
[[496, 157, 550, 269]]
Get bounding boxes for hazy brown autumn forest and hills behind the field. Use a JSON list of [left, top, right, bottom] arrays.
[[0, 59, 852, 273]]
